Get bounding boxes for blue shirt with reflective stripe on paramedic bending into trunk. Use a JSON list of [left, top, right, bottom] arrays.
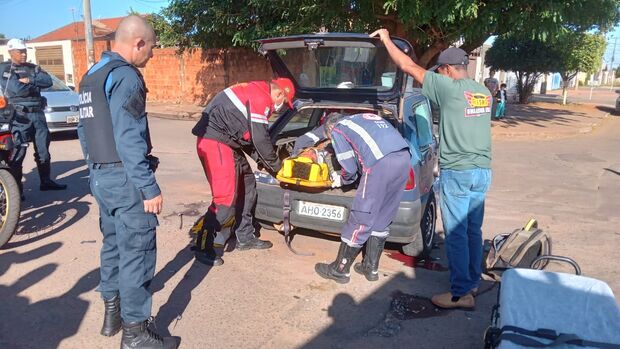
[[331, 114, 409, 184]]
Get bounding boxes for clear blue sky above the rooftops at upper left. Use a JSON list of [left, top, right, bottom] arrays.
[[0, 0, 168, 39]]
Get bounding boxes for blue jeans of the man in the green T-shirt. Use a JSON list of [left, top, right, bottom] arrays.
[[439, 168, 492, 297]]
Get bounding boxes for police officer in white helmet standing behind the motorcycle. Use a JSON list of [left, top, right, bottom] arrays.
[[0, 39, 67, 195]]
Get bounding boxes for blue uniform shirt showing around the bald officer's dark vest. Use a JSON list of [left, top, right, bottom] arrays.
[[78, 51, 161, 200]]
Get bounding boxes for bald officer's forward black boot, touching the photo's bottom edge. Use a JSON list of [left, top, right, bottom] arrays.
[[121, 320, 180, 349]]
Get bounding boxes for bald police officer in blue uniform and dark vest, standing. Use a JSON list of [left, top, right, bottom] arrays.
[[78, 16, 178, 349]]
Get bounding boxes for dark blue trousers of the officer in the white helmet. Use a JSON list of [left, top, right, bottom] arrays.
[[12, 112, 51, 167]]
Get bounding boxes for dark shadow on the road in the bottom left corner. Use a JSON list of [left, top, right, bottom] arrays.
[[0, 243, 99, 349]]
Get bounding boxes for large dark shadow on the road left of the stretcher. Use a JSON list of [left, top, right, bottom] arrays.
[[300, 271, 497, 349]]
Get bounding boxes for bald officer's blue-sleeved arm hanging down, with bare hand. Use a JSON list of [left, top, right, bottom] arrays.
[[106, 68, 162, 214]]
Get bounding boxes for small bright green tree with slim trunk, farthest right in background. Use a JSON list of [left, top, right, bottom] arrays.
[[553, 32, 606, 104]]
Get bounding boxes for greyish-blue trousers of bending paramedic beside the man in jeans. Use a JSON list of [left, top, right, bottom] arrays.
[[340, 150, 411, 247]]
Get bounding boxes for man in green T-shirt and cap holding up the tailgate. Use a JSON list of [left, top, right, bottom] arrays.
[[370, 29, 492, 308]]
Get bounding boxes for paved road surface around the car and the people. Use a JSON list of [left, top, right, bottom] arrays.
[[0, 113, 620, 349]]
